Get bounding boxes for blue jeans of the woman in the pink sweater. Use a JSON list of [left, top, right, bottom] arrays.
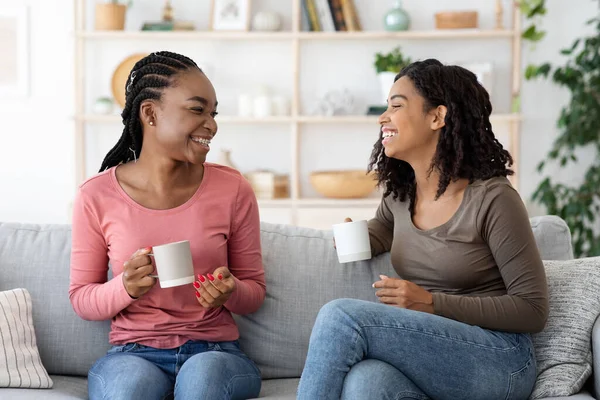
[[88, 341, 261, 400]]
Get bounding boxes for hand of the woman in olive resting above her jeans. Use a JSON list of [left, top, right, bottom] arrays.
[[373, 275, 433, 314]]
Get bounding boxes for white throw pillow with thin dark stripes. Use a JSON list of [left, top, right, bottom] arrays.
[[0, 289, 53, 389]]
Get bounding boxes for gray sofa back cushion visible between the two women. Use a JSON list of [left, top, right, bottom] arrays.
[[237, 223, 393, 379]]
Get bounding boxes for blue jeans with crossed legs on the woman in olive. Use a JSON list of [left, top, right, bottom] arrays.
[[298, 299, 536, 400]]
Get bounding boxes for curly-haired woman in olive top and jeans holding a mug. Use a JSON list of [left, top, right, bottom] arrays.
[[298, 60, 548, 400]]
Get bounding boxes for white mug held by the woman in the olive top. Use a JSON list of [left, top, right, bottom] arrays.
[[333, 220, 371, 263]]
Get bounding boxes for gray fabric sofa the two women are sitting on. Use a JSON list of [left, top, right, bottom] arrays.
[[0, 217, 600, 400]]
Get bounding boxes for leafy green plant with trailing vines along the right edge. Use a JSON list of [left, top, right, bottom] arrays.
[[519, 0, 600, 257]]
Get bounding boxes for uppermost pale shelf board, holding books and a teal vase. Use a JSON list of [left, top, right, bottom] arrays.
[[75, 29, 515, 41]]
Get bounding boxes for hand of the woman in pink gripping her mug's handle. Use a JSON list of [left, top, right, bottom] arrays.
[[123, 247, 156, 299]]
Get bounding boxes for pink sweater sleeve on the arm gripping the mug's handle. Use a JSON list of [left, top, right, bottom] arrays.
[[69, 189, 134, 321]]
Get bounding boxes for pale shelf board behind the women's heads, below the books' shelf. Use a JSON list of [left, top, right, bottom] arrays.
[[76, 114, 521, 125]]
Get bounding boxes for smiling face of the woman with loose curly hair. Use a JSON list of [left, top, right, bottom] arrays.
[[379, 76, 445, 163]]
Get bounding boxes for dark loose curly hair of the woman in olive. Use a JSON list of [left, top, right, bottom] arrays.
[[368, 59, 513, 211]]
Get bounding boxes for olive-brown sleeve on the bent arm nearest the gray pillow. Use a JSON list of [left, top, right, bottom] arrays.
[[433, 185, 548, 333]]
